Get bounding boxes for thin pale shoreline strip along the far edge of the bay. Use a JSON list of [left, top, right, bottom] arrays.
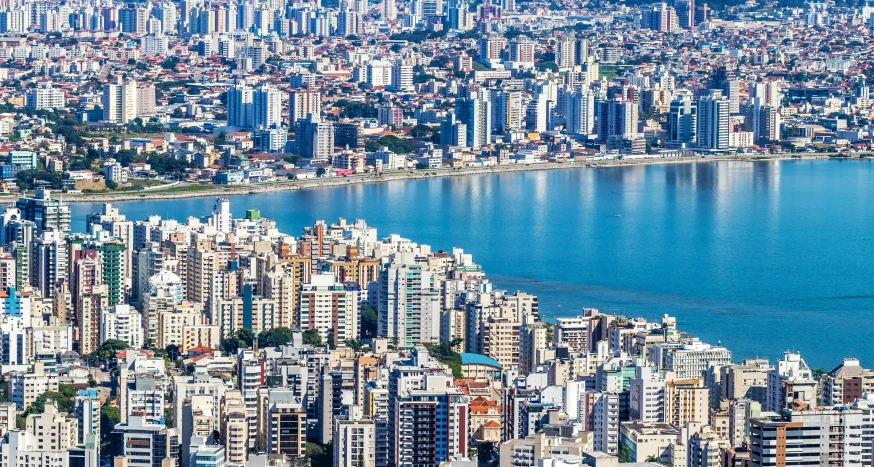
[[52, 154, 829, 203]]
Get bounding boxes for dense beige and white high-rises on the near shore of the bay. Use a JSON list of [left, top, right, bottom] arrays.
[[0, 195, 874, 467]]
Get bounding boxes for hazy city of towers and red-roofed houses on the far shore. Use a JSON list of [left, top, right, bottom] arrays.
[[0, 0, 874, 190]]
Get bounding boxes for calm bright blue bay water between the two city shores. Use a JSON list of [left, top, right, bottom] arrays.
[[73, 160, 874, 368]]
